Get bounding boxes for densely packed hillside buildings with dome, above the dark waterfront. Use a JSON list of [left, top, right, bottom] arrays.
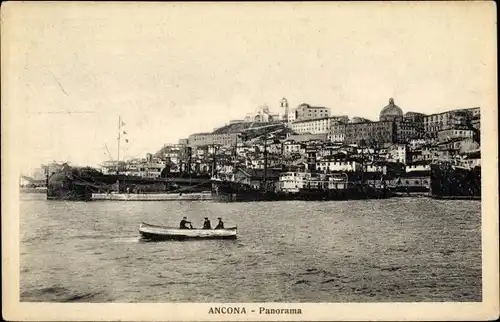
[[95, 98, 481, 185]]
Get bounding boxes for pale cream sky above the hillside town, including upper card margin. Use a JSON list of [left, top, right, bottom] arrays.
[[2, 2, 496, 172]]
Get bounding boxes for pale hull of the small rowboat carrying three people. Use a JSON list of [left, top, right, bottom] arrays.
[[139, 222, 237, 241]]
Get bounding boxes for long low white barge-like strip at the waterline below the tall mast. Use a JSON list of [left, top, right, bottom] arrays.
[[92, 192, 212, 201]]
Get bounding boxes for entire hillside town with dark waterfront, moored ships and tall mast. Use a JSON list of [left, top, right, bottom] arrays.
[[21, 98, 481, 202]]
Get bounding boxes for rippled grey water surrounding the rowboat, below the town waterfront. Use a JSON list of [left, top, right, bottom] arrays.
[[20, 195, 481, 302]]
